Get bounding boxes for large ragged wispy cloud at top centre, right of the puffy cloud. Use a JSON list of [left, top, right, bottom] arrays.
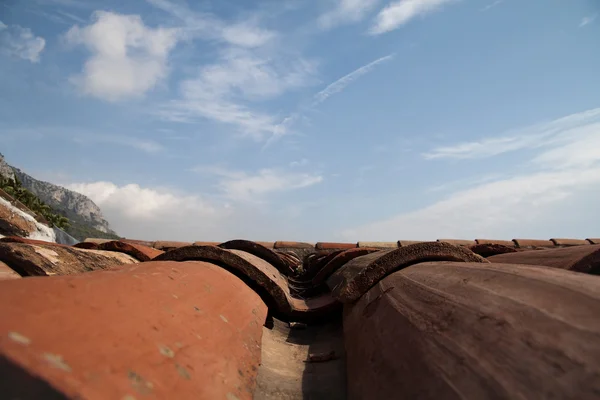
[[147, 0, 316, 140]]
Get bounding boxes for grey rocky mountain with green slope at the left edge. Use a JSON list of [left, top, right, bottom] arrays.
[[0, 155, 118, 240]]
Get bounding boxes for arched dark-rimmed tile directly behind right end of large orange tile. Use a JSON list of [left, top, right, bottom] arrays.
[[155, 246, 292, 315]]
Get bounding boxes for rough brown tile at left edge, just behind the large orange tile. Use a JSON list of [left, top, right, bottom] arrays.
[[0, 243, 138, 276]]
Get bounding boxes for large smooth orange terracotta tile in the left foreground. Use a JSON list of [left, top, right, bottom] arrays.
[[0, 261, 267, 399]]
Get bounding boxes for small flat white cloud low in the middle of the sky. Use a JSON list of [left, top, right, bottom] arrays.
[[194, 166, 323, 202]]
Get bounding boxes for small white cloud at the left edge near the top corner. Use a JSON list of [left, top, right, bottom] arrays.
[[0, 21, 46, 63]]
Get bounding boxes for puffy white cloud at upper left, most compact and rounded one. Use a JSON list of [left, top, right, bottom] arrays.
[[65, 11, 178, 101]]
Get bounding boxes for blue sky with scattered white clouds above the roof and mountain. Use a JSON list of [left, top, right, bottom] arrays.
[[0, 0, 600, 241]]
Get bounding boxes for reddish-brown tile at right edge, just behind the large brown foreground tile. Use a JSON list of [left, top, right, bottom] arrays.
[[488, 245, 600, 274]]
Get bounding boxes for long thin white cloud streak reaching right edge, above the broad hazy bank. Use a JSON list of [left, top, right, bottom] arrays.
[[424, 108, 600, 159]]
